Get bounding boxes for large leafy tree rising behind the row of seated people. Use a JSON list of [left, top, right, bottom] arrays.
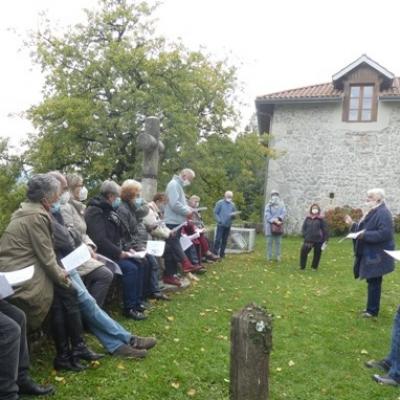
[[27, 0, 237, 181]]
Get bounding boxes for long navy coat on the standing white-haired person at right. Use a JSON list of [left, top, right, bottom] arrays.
[[351, 203, 394, 279]]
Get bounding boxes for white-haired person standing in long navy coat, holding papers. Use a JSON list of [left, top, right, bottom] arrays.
[[345, 189, 394, 318]]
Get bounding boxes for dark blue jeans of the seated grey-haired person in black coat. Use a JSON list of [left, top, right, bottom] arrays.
[[117, 258, 144, 311]]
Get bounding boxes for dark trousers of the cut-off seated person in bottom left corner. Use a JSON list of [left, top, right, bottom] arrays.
[[0, 300, 29, 400]]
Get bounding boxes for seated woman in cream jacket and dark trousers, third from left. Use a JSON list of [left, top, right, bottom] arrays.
[[61, 175, 113, 307]]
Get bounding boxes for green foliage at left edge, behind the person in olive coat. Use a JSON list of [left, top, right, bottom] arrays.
[[0, 139, 26, 235]]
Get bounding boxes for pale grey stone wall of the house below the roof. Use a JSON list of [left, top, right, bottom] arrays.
[[267, 102, 400, 233]]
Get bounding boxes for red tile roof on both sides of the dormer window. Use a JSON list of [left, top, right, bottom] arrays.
[[256, 77, 400, 103]]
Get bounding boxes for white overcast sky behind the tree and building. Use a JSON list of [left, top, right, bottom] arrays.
[[0, 0, 400, 151]]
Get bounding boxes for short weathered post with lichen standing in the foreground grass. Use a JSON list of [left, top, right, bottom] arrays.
[[229, 304, 272, 400]]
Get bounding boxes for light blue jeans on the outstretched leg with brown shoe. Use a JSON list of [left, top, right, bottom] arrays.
[[69, 270, 132, 353]]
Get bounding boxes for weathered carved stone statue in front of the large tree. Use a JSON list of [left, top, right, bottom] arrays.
[[137, 117, 164, 201]]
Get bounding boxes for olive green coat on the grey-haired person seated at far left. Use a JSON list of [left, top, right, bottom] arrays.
[[0, 202, 68, 330]]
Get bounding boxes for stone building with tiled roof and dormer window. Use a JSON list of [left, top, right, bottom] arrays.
[[256, 55, 400, 232]]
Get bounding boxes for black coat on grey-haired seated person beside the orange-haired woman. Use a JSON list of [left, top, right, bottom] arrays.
[[85, 196, 122, 261]]
